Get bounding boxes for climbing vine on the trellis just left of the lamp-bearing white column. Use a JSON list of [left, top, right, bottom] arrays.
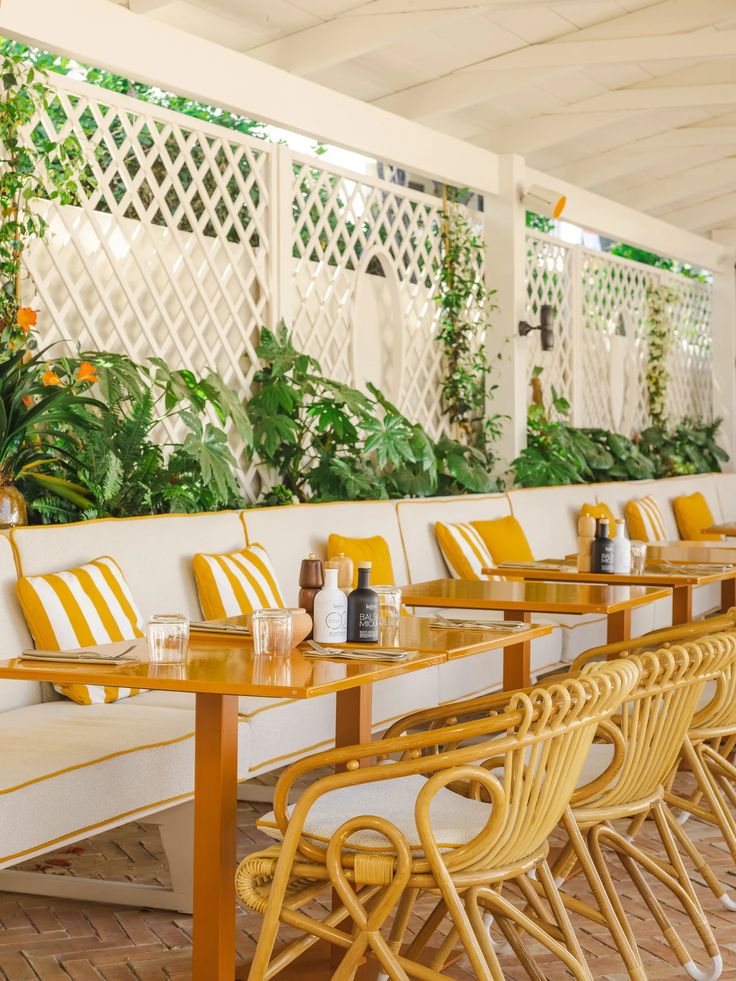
[[435, 192, 501, 455]]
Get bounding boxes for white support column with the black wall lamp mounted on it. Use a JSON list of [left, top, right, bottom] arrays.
[[485, 155, 529, 472]]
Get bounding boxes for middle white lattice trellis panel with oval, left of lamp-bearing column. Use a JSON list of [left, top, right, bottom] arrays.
[[290, 155, 483, 437]]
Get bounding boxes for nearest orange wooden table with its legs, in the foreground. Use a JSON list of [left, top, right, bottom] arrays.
[[0, 617, 549, 981]]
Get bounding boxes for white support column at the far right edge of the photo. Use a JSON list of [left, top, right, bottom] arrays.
[[711, 263, 736, 470]]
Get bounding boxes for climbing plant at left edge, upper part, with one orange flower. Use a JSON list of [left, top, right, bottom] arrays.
[[0, 44, 84, 358]]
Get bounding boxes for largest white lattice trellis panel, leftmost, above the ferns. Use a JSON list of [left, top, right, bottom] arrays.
[[24, 72, 273, 496]]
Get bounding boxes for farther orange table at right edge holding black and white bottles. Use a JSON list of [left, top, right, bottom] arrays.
[[483, 559, 736, 626]]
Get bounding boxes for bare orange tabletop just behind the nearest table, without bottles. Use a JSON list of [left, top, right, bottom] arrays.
[[401, 579, 670, 614]]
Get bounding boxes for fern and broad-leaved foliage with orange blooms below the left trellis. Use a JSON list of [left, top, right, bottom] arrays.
[[25, 352, 251, 521]]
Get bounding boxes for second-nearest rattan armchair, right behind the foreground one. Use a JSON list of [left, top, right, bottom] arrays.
[[553, 634, 736, 981]]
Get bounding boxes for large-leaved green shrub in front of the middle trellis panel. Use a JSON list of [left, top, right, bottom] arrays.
[[247, 323, 494, 503]]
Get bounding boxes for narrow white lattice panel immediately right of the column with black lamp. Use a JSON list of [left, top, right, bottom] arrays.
[[526, 234, 575, 404]]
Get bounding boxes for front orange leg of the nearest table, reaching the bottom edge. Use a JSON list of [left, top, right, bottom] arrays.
[[192, 694, 238, 981]]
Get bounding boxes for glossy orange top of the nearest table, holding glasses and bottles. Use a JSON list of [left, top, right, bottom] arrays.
[[0, 617, 551, 698]]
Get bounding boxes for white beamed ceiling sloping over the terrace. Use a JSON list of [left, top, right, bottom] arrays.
[[111, 0, 736, 241]]
